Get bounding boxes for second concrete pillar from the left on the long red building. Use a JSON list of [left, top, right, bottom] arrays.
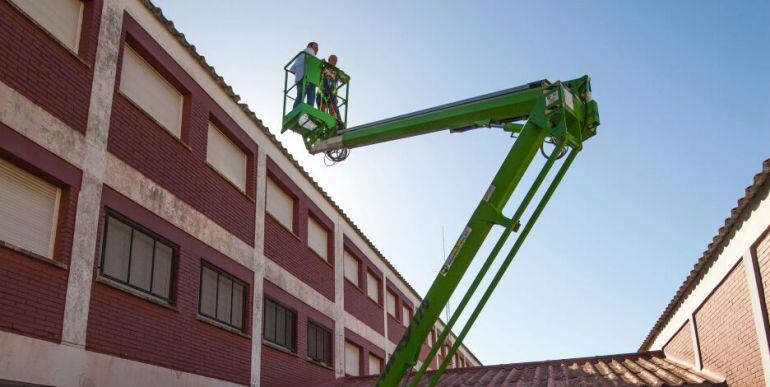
[[251, 149, 267, 387]]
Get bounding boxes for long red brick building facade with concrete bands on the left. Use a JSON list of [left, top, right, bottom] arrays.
[[0, 0, 479, 386]]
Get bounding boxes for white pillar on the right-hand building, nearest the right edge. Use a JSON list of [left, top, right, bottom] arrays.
[[743, 247, 770, 385]]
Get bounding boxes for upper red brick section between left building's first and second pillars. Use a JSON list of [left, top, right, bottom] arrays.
[[107, 16, 257, 246]]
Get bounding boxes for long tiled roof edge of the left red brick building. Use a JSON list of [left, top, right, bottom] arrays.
[[140, 0, 481, 364]]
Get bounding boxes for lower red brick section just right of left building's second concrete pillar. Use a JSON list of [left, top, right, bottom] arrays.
[[257, 281, 332, 387]]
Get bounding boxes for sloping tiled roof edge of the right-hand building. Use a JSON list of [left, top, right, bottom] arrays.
[[639, 159, 770, 351]]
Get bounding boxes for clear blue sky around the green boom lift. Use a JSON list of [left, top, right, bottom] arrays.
[[152, 0, 770, 364]]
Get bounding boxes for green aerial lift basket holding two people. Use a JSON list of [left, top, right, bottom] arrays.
[[281, 51, 350, 153]]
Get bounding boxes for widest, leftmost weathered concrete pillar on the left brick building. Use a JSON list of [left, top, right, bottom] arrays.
[[62, 0, 124, 347]]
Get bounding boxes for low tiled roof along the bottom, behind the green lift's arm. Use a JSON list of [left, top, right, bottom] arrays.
[[326, 351, 724, 387]]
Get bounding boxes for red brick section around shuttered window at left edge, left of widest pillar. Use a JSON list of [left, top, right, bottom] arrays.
[[0, 123, 82, 341]]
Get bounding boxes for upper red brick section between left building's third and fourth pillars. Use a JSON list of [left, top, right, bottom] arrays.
[[344, 237, 385, 334]]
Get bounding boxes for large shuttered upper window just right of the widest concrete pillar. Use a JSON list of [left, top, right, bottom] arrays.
[[120, 45, 183, 138]]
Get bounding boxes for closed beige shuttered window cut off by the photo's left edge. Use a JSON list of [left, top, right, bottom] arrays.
[[0, 159, 61, 258]]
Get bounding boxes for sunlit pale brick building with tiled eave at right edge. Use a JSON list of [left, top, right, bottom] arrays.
[[640, 160, 770, 386]]
